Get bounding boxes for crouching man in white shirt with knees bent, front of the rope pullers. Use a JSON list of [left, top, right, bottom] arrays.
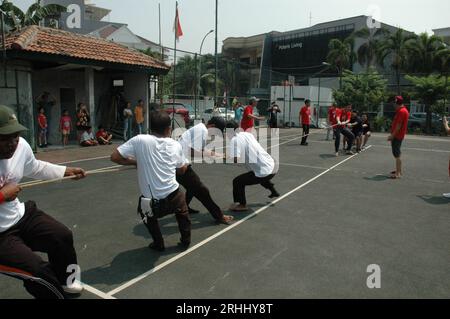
[[227, 122, 280, 211]]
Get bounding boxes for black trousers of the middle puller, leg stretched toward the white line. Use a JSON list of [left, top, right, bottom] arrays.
[[177, 166, 223, 220]]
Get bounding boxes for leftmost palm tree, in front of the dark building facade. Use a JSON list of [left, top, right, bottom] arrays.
[[327, 37, 356, 88]]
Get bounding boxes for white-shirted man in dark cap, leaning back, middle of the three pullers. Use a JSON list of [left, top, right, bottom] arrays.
[[177, 117, 233, 225]]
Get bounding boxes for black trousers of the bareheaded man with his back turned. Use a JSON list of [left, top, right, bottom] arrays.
[[138, 190, 191, 247]]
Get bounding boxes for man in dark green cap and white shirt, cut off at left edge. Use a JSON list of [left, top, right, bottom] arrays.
[[0, 106, 85, 299]]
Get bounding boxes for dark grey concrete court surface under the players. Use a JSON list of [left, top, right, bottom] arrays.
[[0, 129, 450, 299]]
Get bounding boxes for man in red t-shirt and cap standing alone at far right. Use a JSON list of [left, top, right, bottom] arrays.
[[388, 96, 409, 179]]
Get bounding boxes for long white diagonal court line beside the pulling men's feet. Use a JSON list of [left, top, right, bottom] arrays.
[[107, 146, 371, 296]]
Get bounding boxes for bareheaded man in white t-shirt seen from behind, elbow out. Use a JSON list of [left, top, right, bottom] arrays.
[[111, 111, 191, 251]]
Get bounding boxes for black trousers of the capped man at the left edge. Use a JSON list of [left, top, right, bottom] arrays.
[[0, 202, 77, 299]]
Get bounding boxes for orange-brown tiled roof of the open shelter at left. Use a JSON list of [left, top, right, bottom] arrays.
[[6, 26, 169, 71]]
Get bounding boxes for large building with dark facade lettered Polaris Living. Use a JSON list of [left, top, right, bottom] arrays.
[[223, 15, 410, 98]]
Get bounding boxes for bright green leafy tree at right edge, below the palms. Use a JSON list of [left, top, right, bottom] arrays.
[[406, 74, 449, 133]]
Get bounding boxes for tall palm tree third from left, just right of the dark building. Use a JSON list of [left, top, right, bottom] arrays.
[[377, 29, 415, 94]]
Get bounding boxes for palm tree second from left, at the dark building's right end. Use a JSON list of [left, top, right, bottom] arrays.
[[352, 28, 389, 72]]
